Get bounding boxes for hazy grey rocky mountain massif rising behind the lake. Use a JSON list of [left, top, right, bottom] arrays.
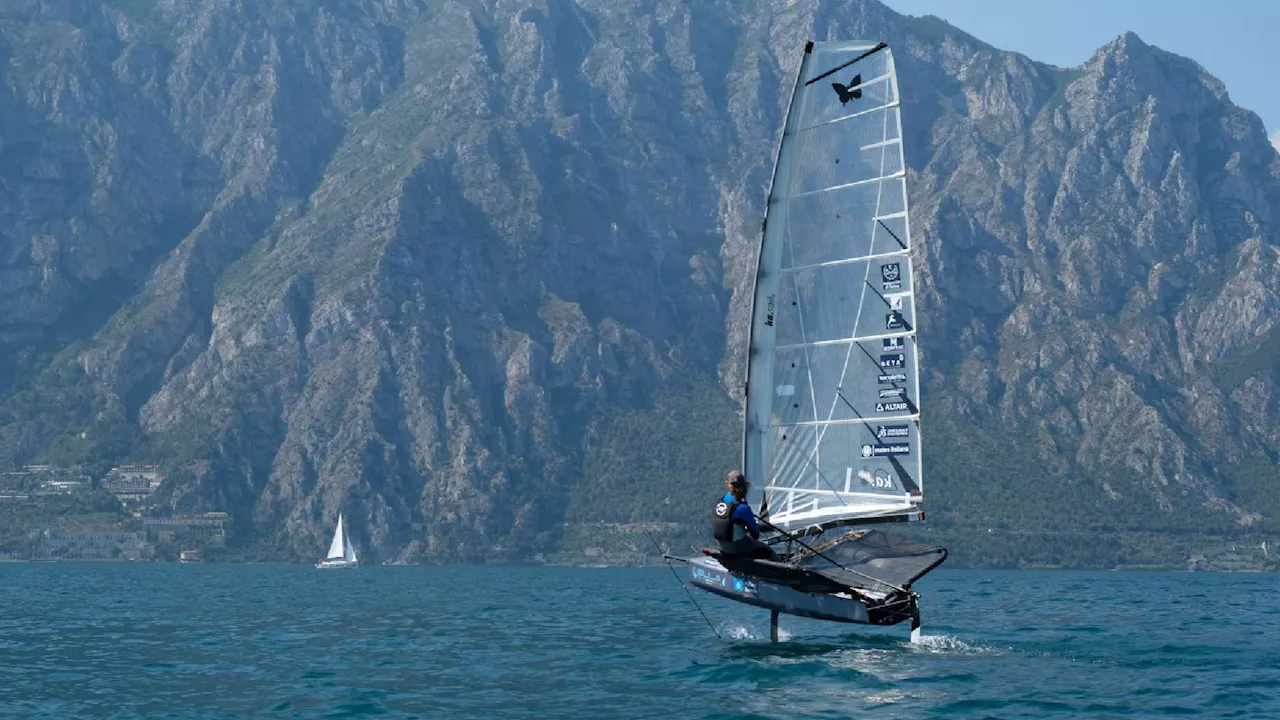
[[0, 0, 1280, 561]]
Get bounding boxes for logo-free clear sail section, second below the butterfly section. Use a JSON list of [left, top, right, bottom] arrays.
[[771, 178, 911, 270]]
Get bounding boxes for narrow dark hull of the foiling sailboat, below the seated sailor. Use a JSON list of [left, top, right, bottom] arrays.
[[689, 557, 882, 625]]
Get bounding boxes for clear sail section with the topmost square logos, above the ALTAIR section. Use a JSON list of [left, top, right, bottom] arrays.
[[774, 254, 915, 347]]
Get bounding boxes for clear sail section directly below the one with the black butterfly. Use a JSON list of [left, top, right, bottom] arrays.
[[787, 109, 902, 196]]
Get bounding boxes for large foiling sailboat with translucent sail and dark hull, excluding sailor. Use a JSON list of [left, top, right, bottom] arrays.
[[686, 42, 947, 639]]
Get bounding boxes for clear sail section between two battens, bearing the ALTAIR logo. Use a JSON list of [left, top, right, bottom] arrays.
[[772, 337, 919, 432]]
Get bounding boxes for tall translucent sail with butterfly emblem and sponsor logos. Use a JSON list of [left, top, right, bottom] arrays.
[[744, 42, 923, 530]]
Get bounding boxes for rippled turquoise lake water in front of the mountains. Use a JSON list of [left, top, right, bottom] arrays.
[[0, 564, 1280, 720]]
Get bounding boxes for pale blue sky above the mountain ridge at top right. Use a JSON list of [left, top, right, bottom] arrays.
[[884, 0, 1280, 149]]
